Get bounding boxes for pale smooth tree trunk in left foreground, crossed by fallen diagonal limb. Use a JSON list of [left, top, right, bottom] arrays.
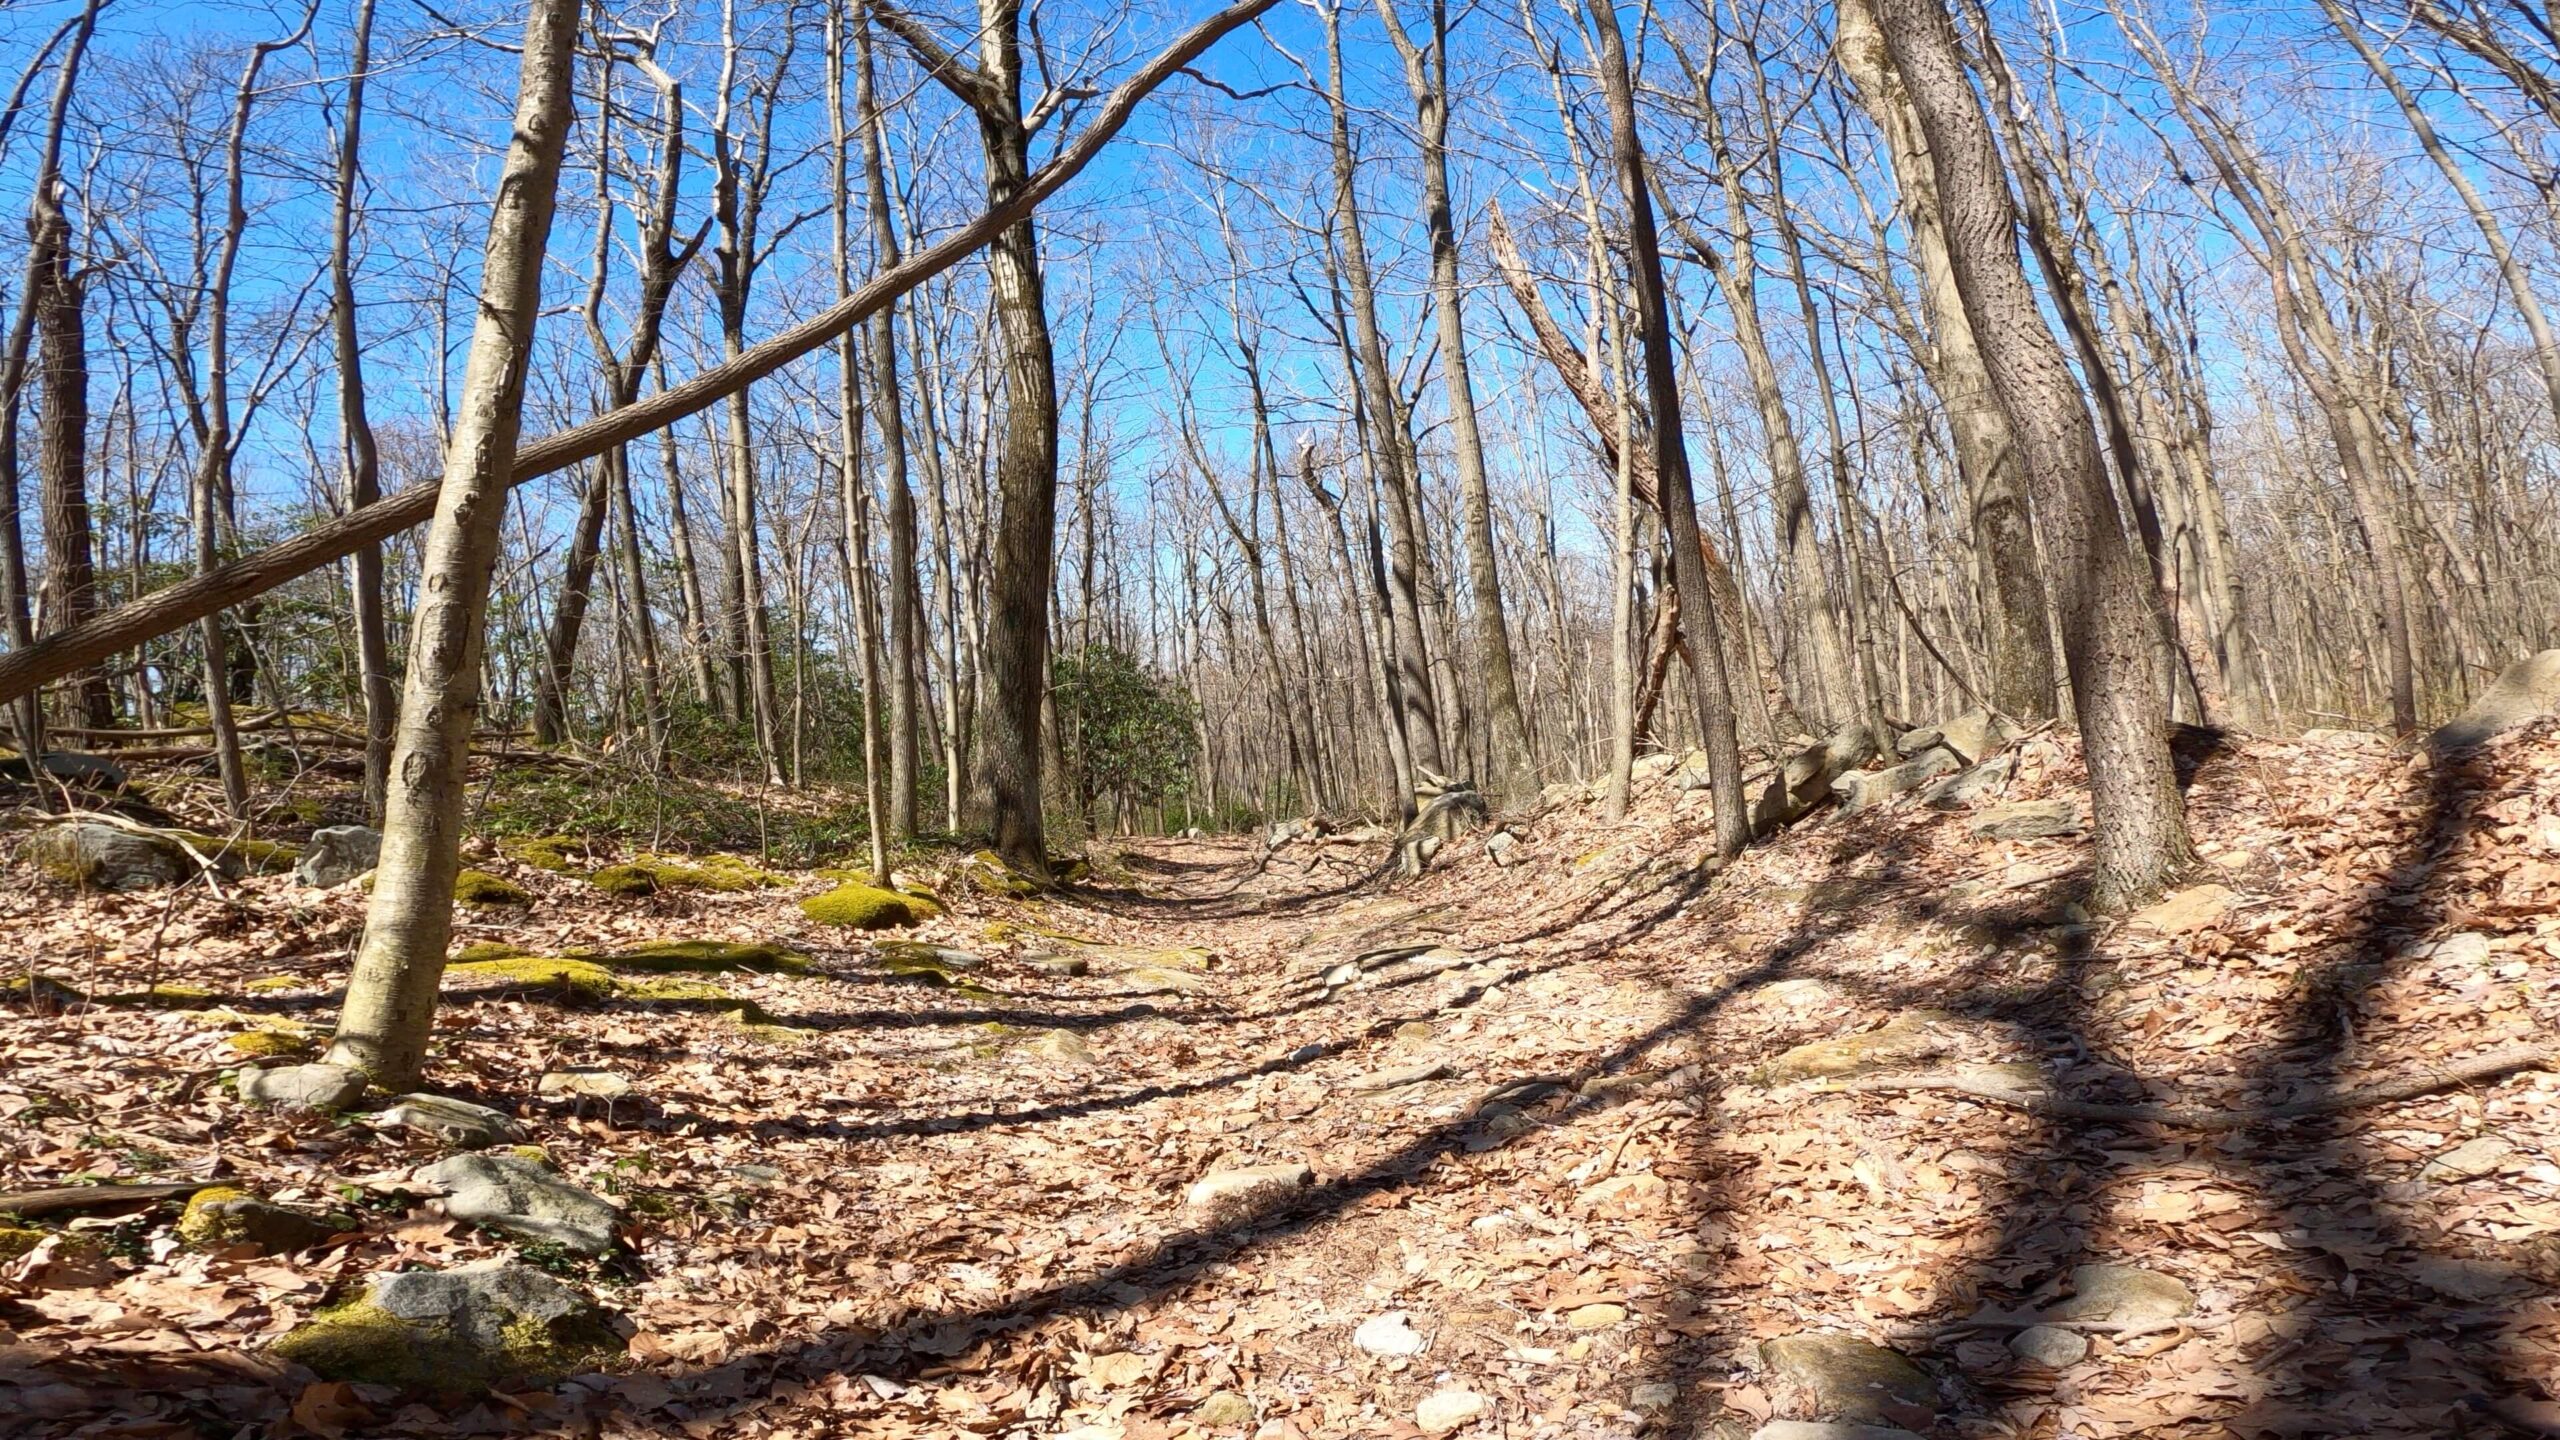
[[330, 0, 581, 1089]]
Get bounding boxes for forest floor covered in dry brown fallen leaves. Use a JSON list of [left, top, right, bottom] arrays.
[[0, 723, 2560, 1440]]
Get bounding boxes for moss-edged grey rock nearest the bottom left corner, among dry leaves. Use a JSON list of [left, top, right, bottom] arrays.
[[274, 1261, 625, 1391]]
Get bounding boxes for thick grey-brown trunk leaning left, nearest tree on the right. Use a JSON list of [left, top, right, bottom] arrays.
[[1876, 0, 2194, 907]]
